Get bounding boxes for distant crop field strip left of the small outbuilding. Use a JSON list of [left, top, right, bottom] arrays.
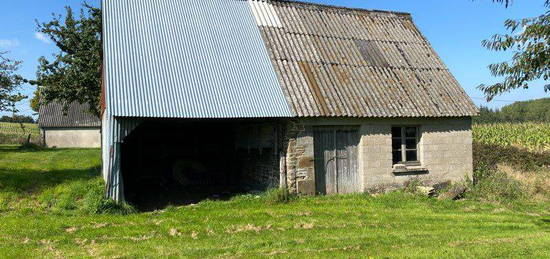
[[0, 122, 40, 144]]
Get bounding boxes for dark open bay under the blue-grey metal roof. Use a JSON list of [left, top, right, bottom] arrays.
[[121, 120, 278, 211]]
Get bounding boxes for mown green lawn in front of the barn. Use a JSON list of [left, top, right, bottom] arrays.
[[0, 146, 550, 258]]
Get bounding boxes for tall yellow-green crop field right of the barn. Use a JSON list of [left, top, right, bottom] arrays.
[[473, 123, 550, 151]]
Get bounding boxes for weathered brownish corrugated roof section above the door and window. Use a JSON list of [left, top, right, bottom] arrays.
[[249, 0, 478, 117]]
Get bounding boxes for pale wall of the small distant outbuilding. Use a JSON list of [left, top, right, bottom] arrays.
[[43, 128, 101, 148]]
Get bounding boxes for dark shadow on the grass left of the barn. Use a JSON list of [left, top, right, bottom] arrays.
[[0, 167, 100, 194]]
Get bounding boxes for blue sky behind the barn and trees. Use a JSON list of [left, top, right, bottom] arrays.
[[0, 0, 550, 118]]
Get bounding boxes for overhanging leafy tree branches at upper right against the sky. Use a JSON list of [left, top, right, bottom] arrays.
[[478, 0, 550, 101]]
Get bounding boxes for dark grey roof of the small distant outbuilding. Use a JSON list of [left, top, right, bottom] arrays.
[[38, 102, 101, 128]]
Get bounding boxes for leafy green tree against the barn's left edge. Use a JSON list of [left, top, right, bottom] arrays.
[[31, 3, 102, 116]]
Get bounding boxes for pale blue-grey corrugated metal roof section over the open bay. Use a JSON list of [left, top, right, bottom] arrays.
[[103, 0, 291, 118]]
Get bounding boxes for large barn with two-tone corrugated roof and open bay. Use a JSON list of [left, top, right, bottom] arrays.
[[102, 0, 477, 207]]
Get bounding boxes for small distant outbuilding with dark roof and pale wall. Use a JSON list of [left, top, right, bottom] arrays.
[[38, 102, 101, 148]]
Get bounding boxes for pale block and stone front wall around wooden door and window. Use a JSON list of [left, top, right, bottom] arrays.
[[285, 118, 473, 194]]
